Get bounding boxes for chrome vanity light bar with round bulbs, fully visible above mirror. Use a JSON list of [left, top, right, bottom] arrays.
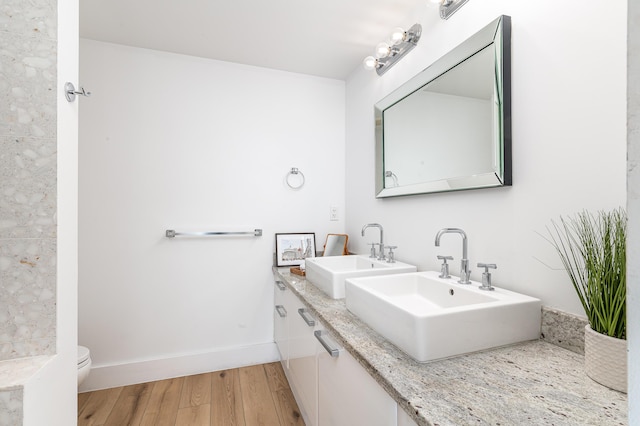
[[362, 24, 422, 75]]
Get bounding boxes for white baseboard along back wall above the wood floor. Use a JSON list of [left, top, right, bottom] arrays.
[[79, 343, 280, 392]]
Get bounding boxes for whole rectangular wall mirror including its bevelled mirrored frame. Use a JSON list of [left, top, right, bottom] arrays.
[[374, 16, 511, 198]]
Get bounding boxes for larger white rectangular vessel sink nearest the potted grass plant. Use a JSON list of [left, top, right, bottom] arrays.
[[345, 272, 541, 362]]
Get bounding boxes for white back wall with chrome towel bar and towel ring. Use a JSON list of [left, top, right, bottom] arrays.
[[79, 40, 345, 387]]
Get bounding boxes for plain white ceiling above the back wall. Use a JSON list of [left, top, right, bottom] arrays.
[[80, 0, 428, 80]]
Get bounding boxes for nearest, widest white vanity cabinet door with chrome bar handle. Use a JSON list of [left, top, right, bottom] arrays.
[[317, 332, 397, 426]]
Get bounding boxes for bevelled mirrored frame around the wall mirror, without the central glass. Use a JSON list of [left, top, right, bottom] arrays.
[[374, 15, 512, 198]]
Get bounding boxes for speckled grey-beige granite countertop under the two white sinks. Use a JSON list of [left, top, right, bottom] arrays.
[[276, 268, 627, 426]]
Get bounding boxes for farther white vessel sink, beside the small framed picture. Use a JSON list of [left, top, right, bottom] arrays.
[[305, 255, 417, 299]]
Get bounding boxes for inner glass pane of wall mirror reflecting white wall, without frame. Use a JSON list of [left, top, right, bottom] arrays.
[[383, 48, 495, 186]]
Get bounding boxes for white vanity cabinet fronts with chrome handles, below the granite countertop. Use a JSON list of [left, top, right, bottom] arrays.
[[274, 274, 415, 426]]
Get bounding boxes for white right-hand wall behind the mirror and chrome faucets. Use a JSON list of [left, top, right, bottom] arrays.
[[346, 0, 626, 314]]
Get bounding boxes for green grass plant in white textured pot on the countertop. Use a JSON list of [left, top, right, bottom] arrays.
[[548, 208, 627, 393]]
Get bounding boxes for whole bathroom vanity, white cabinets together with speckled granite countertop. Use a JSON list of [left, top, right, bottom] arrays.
[[274, 268, 627, 426]]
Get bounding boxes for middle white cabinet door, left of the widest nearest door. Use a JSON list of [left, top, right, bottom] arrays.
[[286, 291, 318, 426]]
